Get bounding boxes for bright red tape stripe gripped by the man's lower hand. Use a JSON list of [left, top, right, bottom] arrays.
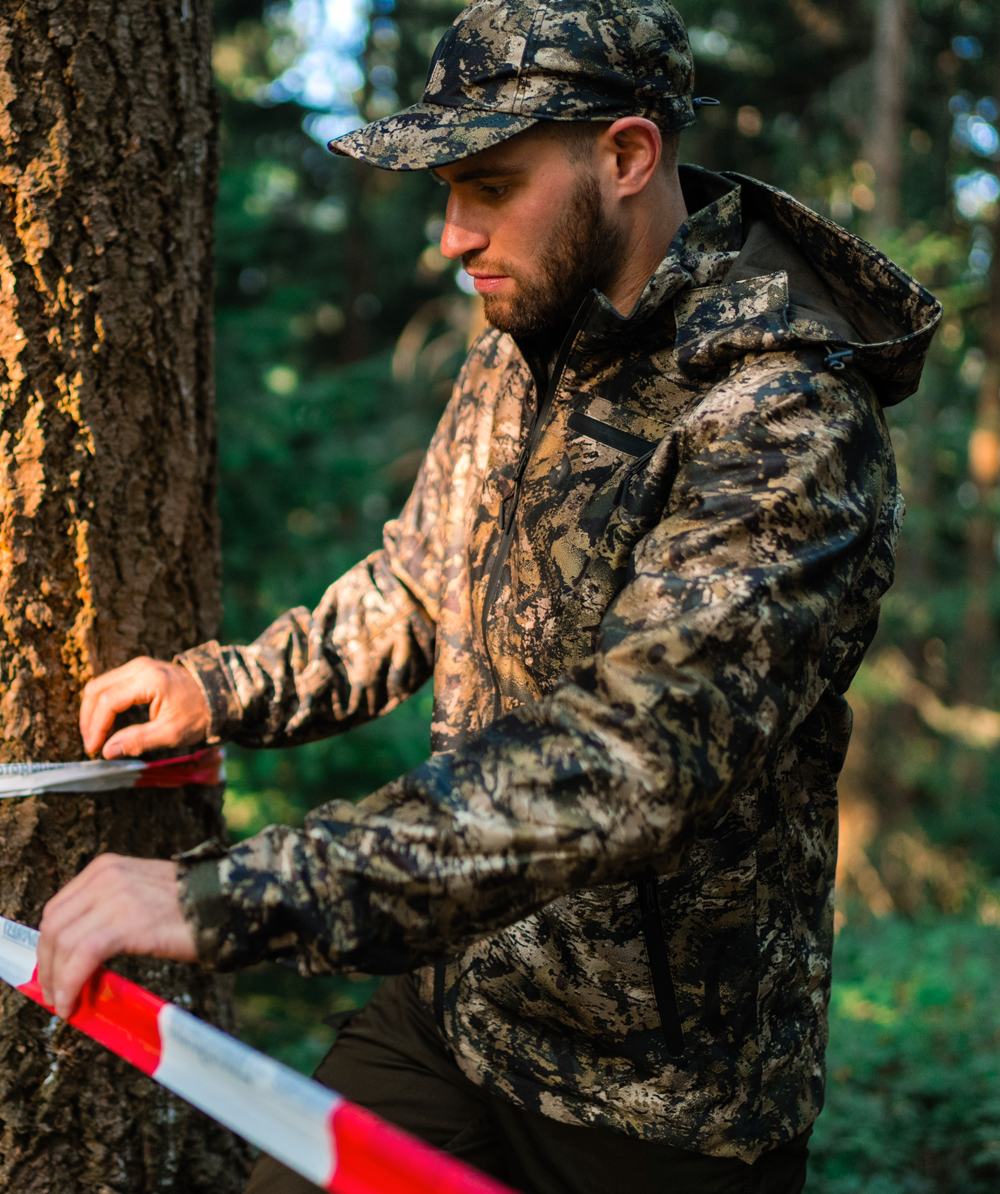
[[18, 967, 166, 1075]]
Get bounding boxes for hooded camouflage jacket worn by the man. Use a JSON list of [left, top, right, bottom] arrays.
[[180, 168, 940, 1161]]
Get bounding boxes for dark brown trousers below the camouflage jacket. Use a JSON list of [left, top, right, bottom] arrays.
[[246, 975, 809, 1194]]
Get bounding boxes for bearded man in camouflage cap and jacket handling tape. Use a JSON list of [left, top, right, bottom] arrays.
[[33, 0, 939, 1194]]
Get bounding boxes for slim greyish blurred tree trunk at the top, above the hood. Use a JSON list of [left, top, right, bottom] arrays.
[[865, 0, 909, 235]]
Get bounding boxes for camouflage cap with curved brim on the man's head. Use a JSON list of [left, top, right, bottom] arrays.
[[329, 0, 695, 170]]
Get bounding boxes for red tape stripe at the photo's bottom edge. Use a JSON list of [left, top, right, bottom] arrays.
[[326, 1103, 512, 1194]]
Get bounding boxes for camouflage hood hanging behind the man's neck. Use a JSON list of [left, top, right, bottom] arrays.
[[585, 166, 942, 406]]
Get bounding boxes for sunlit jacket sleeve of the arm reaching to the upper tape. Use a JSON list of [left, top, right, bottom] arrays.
[[177, 404, 463, 746]]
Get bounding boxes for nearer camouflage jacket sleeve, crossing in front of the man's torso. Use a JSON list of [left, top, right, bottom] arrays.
[[181, 353, 900, 973]]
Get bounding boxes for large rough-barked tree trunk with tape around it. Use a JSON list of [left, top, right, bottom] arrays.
[[0, 0, 245, 1194]]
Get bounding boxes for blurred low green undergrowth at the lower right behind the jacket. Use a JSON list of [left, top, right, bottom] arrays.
[[807, 913, 1000, 1194]]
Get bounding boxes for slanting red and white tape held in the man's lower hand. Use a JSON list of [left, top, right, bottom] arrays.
[[0, 916, 511, 1194]]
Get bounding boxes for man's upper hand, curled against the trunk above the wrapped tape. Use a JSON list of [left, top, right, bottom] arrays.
[[80, 656, 211, 758]]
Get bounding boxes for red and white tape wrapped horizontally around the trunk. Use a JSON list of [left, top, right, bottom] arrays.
[[0, 746, 226, 798]]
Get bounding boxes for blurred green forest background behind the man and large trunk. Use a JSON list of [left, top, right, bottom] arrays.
[[215, 0, 1000, 1194]]
